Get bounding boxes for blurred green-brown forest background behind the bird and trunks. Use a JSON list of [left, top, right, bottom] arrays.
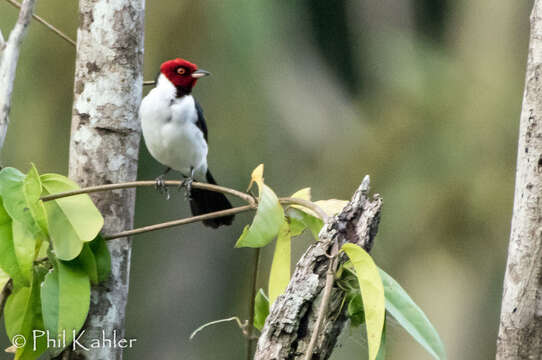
[[0, 0, 532, 360]]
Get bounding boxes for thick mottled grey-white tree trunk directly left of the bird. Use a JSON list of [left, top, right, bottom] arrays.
[[64, 0, 145, 360]]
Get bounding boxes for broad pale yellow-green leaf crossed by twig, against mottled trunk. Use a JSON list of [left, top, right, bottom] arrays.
[[41, 174, 104, 260]]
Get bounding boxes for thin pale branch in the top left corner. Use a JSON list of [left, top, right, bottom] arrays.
[[0, 0, 36, 149]]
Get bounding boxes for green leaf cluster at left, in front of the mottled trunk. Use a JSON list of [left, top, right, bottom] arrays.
[[0, 165, 111, 360]]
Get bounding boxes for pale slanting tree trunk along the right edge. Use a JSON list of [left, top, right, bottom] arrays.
[[497, 0, 542, 359]]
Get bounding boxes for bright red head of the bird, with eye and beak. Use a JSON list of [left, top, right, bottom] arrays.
[[160, 58, 210, 94]]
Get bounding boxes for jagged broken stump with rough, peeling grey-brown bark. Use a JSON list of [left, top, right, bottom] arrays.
[[254, 177, 382, 360]]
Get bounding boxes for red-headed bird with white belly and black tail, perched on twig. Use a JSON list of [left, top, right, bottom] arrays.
[[139, 58, 233, 228]]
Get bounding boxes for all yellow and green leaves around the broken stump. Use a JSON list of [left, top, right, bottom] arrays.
[[236, 165, 446, 360]]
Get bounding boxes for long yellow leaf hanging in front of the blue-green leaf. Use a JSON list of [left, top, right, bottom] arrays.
[[342, 243, 386, 360]]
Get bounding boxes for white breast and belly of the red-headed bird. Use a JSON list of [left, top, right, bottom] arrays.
[[139, 74, 208, 180]]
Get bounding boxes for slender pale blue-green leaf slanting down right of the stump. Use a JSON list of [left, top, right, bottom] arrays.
[[379, 269, 446, 359]]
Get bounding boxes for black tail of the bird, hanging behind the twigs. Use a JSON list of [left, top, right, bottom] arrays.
[[190, 170, 233, 228]]
